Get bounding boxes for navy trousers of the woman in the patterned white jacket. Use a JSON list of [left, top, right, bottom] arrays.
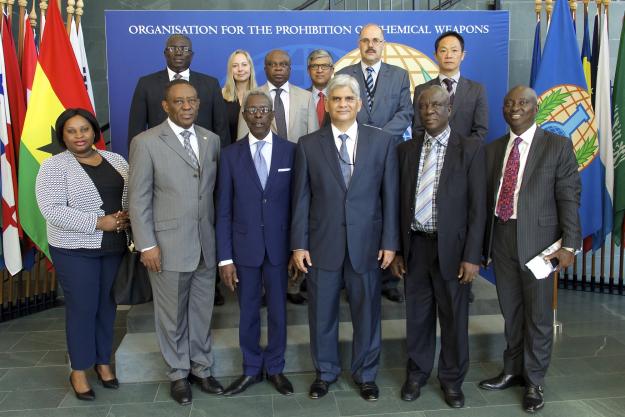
[[50, 246, 122, 370]]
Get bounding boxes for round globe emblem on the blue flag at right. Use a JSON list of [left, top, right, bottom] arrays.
[[536, 84, 599, 171]]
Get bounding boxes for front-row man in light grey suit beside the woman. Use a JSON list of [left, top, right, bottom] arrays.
[[128, 80, 223, 405]]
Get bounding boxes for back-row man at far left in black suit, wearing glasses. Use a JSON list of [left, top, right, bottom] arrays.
[[128, 34, 230, 146]]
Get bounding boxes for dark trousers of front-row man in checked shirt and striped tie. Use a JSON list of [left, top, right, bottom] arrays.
[[405, 234, 470, 389]]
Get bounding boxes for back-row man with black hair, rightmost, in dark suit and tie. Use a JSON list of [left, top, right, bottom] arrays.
[[412, 31, 488, 141]]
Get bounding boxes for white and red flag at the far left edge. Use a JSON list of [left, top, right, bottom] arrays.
[[0, 20, 22, 275]]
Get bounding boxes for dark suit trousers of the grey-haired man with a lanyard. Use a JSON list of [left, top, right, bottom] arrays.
[[307, 256, 381, 383]]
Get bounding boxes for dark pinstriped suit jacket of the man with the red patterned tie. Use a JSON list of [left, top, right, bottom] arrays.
[[484, 128, 582, 269]]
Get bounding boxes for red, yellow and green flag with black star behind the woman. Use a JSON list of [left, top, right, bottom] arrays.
[[18, 1, 104, 258]]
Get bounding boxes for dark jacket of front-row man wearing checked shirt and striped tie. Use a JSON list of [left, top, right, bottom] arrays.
[[397, 129, 486, 280]]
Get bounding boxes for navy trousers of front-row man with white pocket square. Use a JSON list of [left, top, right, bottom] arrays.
[[237, 256, 288, 376]]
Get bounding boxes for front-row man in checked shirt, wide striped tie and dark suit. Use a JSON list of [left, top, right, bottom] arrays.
[[392, 86, 486, 408]]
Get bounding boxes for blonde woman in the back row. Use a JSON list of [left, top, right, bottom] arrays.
[[221, 49, 256, 142]]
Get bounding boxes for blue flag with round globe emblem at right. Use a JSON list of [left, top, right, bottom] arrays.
[[535, 0, 603, 237]]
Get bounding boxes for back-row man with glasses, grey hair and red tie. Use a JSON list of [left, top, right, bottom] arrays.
[[308, 49, 334, 127]]
